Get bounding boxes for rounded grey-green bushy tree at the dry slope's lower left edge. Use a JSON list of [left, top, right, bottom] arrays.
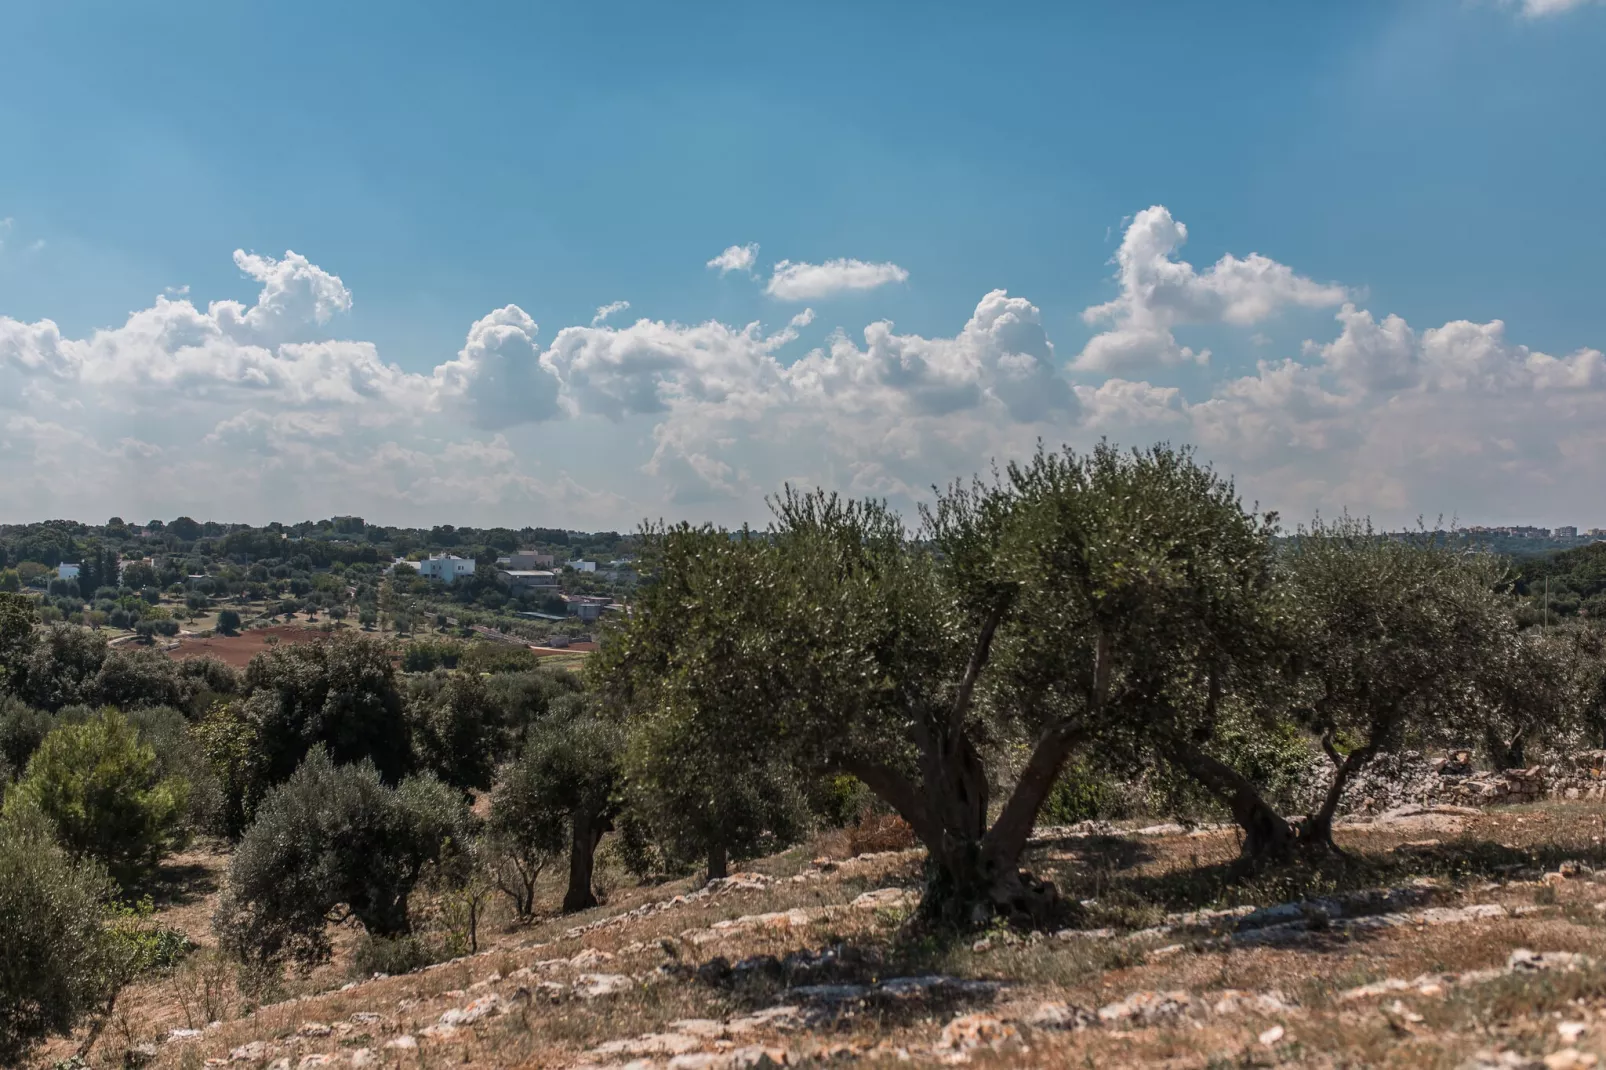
[[212, 749, 469, 962]]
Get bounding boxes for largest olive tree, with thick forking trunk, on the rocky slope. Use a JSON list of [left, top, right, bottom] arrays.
[[599, 445, 1274, 925]]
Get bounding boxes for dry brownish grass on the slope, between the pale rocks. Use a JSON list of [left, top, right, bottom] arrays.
[[34, 803, 1606, 1070]]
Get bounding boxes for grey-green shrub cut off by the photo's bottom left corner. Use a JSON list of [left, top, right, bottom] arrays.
[[0, 811, 109, 1067]]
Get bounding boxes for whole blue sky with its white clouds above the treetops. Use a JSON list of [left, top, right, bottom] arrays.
[[0, 0, 1606, 530]]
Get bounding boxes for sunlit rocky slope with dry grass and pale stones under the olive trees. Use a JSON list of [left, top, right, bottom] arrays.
[[47, 802, 1606, 1070]]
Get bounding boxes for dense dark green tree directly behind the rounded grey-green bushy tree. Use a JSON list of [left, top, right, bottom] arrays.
[[244, 635, 413, 784]]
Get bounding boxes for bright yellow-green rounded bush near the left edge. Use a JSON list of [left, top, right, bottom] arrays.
[[5, 709, 190, 884]]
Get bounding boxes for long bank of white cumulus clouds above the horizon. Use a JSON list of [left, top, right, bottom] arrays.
[[0, 215, 1606, 527]]
